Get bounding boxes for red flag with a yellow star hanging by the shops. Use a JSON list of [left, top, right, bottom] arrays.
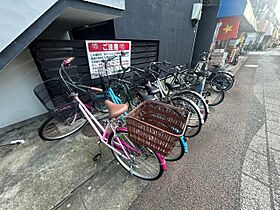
[[217, 16, 240, 41]]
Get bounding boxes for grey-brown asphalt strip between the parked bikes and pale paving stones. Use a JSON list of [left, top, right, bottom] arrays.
[[130, 55, 265, 209]]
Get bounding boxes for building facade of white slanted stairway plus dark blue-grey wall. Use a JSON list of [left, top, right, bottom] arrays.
[[0, 0, 219, 128]]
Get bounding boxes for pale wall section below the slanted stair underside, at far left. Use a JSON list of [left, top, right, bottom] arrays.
[[0, 49, 46, 128]]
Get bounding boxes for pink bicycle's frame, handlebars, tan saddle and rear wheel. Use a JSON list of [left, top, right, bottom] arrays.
[[59, 57, 166, 181]]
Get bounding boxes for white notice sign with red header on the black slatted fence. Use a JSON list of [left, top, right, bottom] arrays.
[[86, 40, 131, 79]]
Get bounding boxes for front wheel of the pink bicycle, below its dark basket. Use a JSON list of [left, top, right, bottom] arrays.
[[38, 104, 87, 141]]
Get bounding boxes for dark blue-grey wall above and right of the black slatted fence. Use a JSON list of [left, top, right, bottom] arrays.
[[115, 0, 199, 63]]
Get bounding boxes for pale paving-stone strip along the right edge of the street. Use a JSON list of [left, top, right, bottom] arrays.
[[240, 51, 280, 209]]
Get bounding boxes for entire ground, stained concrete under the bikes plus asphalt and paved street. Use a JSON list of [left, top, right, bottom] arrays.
[[0, 51, 280, 210]]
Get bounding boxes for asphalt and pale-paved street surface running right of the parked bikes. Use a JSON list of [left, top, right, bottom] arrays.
[[130, 51, 280, 209]]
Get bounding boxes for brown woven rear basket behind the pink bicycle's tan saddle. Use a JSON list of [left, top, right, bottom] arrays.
[[126, 101, 189, 156]]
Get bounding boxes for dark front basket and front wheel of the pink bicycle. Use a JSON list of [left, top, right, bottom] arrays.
[[33, 79, 92, 141]]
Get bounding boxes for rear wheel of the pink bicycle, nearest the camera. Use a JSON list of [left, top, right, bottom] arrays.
[[108, 130, 163, 181]]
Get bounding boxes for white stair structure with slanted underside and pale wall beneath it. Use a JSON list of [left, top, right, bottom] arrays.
[[0, 0, 125, 128]]
